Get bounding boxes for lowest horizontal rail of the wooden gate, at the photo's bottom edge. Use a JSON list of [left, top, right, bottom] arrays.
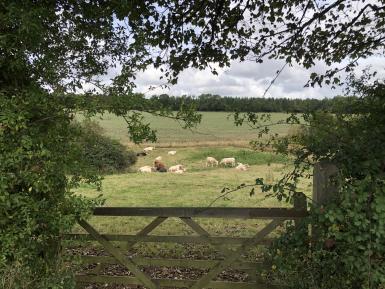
[[76, 275, 270, 289]]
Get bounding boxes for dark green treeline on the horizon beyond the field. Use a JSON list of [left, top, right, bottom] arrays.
[[151, 94, 353, 112]]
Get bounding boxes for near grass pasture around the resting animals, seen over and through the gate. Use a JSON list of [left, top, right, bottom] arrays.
[[78, 147, 311, 236]]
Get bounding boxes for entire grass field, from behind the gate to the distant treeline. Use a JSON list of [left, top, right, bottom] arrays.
[[75, 113, 311, 255]]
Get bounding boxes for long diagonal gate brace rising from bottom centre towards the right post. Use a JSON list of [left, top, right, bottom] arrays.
[[189, 220, 282, 289]]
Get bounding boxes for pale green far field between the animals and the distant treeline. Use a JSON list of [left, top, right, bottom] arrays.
[[79, 112, 289, 147]]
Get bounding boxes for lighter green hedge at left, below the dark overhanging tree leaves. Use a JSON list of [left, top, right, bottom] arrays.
[[0, 88, 100, 288]]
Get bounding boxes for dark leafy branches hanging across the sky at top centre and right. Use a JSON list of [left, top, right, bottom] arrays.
[[106, 0, 385, 85]]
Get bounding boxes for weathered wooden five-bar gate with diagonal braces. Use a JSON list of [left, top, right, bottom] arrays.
[[66, 199, 307, 289]]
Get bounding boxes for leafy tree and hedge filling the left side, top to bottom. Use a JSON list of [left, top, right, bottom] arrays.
[[0, 0, 200, 288]]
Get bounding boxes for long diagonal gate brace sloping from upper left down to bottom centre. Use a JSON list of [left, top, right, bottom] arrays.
[[78, 220, 158, 289]]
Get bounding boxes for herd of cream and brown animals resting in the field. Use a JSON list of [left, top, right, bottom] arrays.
[[137, 147, 250, 174]]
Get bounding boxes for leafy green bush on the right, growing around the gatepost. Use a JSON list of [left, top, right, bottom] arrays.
[[231, 79, 385, 289]]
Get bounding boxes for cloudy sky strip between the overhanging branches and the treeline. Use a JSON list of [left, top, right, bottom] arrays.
[[131, 56, 385, 99]]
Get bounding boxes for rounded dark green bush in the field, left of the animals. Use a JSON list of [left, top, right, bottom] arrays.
[[75, 120, 137, 174]]
